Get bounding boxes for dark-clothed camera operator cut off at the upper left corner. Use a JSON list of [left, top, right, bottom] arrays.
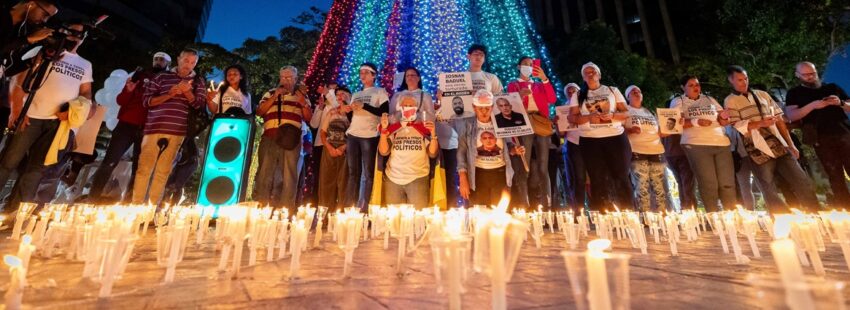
[[0, 0, 59, 128]]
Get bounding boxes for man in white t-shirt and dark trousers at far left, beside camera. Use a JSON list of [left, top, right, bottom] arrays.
[[0, 21, 94, 210]]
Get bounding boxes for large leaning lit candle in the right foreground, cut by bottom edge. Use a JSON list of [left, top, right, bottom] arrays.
[[770, 215, 815, 309]]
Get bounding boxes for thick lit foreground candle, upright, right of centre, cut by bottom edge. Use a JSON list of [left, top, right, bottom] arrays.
[[585, 239, 611, 310]]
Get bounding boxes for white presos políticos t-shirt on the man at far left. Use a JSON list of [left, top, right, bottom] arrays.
[[27, 51, 93, 119]]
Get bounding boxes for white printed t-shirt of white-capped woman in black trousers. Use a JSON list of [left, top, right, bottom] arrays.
[[570, 85, 626, 138]]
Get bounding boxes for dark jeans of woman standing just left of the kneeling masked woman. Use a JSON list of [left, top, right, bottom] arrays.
[[343, 136, 378, 210]]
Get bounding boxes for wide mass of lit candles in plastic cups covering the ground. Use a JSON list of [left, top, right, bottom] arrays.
[[0, 203, 850, 309]]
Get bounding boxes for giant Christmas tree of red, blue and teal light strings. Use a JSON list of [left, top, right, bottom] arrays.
[[306, 0, 561, 95]]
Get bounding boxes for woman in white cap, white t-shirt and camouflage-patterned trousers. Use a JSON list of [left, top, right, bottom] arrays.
[[626, 85, 669, 212]]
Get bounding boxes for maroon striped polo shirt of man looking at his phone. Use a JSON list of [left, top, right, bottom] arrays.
[[142, 69, 207, 136]]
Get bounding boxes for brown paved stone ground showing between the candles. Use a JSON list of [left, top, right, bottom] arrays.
[[0, 224, 850, 310]]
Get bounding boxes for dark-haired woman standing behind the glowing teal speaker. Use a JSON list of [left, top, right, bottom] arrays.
[[207, 64, 254, 114]]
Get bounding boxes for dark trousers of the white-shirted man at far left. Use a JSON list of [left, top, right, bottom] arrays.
[[0, 118, 59, 207]]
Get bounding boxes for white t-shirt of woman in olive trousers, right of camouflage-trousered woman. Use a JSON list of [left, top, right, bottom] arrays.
[[670, 95, 729, 146]]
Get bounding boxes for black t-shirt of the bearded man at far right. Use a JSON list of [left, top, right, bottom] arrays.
[[785, 83, 848, 135]]
